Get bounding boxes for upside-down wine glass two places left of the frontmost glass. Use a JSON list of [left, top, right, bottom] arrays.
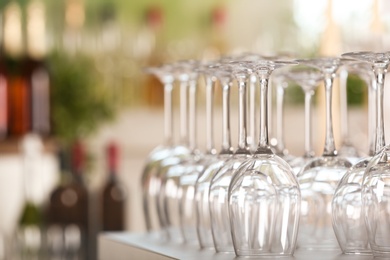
[[195, 66, 233, 249]]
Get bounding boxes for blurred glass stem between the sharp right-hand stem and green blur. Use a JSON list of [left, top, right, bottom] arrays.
[[338, 65, 360, 163]]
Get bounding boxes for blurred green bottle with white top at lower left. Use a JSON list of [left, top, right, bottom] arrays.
[[16, 135, 44, 259]]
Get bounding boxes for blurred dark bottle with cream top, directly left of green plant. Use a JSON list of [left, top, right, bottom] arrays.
[[26, 0, 50, 136]]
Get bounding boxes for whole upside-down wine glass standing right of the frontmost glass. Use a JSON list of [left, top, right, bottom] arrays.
[[297, 57, 352, 250]]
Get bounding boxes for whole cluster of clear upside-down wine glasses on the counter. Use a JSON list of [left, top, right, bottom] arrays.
[[142, 52, 390, 256]]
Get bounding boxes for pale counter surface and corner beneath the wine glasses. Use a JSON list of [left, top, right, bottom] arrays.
[[98, 232, 373, 260]]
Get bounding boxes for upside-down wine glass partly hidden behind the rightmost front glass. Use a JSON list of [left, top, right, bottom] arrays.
[[332, 58, 376, 254]]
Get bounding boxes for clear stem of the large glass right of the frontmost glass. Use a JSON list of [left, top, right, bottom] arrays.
[[323, 73, 337, 156]]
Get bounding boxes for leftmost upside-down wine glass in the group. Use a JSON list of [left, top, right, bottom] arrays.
[[141, 64, 189, 234]]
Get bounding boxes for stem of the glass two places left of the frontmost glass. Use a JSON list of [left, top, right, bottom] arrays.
[[220, 81, 233, 154]]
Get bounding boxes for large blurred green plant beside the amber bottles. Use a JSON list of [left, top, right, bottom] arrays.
[[48, 52, 115, 144]]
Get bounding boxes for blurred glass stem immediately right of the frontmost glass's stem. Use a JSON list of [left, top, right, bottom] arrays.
[[276, 82, 284, 154]]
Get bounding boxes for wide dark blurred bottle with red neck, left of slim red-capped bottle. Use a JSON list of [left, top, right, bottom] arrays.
[[46, 142, 89, 259]]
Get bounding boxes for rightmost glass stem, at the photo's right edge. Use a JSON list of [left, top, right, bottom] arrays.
[[374, 67, 386, 151]]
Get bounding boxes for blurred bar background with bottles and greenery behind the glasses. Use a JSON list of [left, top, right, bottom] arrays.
[[0, 0, 390, 259]]
